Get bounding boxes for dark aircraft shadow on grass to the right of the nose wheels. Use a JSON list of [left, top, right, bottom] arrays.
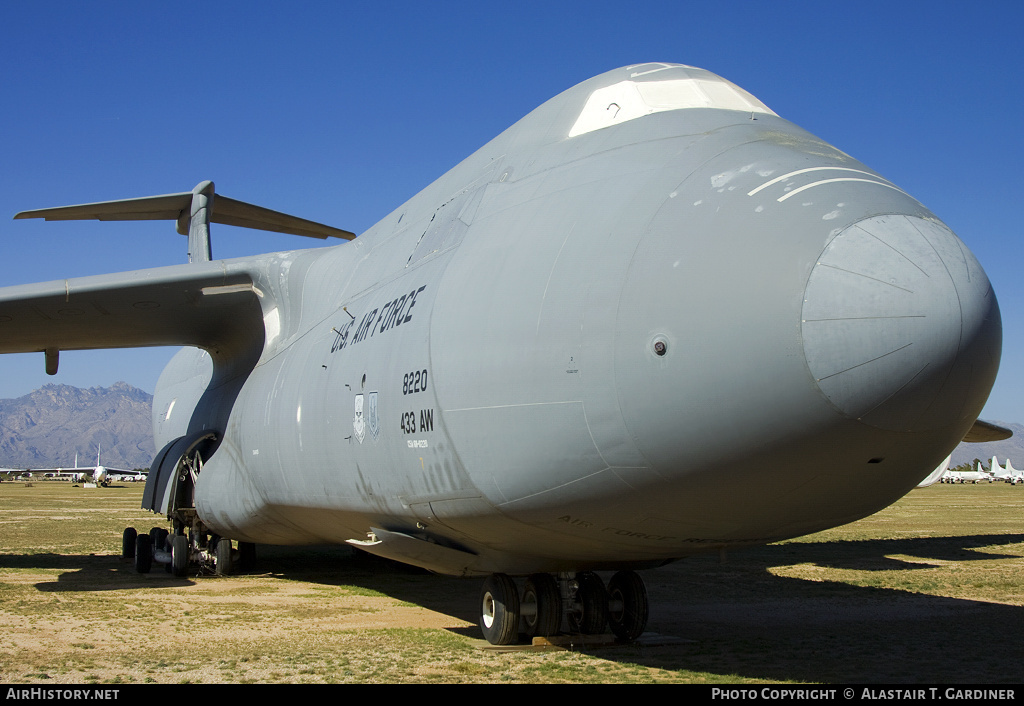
[[636, 534, 1024, 682]]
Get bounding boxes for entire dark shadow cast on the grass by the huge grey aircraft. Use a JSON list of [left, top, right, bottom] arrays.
[[16, 534, 1024, 683]]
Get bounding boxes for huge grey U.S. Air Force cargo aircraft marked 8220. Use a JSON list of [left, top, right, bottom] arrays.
[[0, 64, 1005, 643]]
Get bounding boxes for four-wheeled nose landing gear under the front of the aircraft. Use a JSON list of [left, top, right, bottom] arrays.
[[480, 571, 649, 645]]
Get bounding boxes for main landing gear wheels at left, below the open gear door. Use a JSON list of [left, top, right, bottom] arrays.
[[121, 523, 256, 577]]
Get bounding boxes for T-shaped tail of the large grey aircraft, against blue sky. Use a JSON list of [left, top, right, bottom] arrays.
[[14, 181, 355, 262]]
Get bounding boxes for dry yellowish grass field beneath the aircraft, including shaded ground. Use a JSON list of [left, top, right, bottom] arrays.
[[0, 482, 1024, 683]]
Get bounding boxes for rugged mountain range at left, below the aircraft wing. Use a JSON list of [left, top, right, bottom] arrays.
[[0, 382, 157, 469]]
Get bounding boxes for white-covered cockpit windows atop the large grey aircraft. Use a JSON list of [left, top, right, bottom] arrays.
[[568, 74, 775, 137]]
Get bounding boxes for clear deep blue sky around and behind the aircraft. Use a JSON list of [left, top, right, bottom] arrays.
[[0, 0, 1024, 422]]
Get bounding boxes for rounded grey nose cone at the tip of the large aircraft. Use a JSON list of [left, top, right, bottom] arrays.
[[801, 215, 1001, 431]]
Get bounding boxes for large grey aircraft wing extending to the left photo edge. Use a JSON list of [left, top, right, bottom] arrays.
[[0, 259, 264, 366]]
